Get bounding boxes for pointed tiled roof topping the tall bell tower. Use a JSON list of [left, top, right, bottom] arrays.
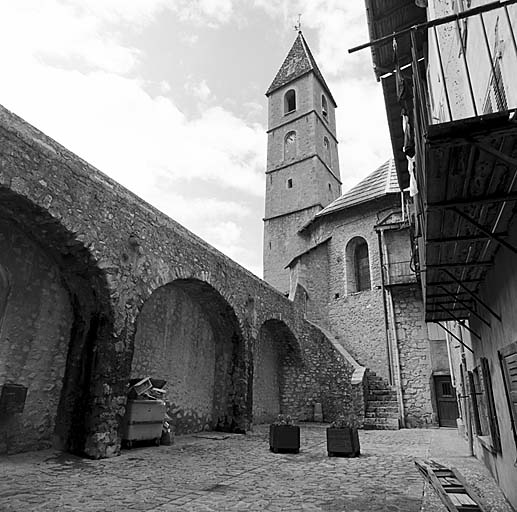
[[266, 30, 337, 107]]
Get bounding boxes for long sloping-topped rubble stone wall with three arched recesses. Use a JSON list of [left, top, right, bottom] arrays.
[[0, 107, 365, 458]]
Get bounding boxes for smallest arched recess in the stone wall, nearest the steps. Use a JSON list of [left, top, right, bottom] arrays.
[[253, 319, 302, 423]]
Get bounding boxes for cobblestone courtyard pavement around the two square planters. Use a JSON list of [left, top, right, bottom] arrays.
[[0, 424, 511, 512]]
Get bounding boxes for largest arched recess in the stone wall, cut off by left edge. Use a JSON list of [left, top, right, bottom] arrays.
[[0, 187, 109, 453]]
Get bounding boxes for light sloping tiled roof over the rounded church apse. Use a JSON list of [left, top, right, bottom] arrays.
[[316, 158, 400, 217]]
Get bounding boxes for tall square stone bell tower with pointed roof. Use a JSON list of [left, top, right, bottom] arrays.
[[264, 31, 341, 293]]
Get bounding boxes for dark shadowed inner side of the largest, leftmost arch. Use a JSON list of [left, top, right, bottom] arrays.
[[0, 187, 113, 455]]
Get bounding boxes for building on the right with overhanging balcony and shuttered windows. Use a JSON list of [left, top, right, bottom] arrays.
[[358, 0, 517, 507]]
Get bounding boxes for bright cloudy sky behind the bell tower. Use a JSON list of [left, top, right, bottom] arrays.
[[0, 0, 390, 276]]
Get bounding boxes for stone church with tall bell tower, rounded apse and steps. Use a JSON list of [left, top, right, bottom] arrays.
[[264, 31, 452, 429]]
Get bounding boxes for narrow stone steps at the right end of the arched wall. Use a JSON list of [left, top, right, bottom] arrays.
[[363, 370, 399, 430]]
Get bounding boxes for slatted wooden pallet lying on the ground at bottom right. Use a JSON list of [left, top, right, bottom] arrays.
[[415, 460, 487, 512]]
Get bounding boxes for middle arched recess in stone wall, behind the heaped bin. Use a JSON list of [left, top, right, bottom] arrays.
[[131, 279, 249, 434]]
